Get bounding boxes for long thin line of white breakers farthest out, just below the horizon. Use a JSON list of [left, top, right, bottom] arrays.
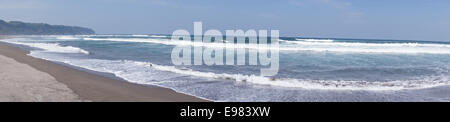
[[84, 38, 450, 54]]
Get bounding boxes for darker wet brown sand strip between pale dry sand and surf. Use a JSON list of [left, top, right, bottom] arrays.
[[0, 36, 208, 102]]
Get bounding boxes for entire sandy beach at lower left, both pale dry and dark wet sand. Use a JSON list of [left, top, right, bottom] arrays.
[[0, 37, 207, 102]]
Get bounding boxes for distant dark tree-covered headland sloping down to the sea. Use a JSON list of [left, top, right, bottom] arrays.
[[0, 19, 95, 35]]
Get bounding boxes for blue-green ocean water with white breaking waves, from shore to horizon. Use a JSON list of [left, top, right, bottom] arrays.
[[2, 35, 450, 101]]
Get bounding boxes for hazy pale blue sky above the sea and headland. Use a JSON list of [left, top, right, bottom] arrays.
[[0, 0, 450, 41]]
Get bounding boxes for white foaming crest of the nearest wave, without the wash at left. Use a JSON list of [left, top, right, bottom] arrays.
[[133, 61, 448, 90]]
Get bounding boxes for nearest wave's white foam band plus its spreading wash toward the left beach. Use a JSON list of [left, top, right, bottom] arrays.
[[24, 50, 449, 91]]
